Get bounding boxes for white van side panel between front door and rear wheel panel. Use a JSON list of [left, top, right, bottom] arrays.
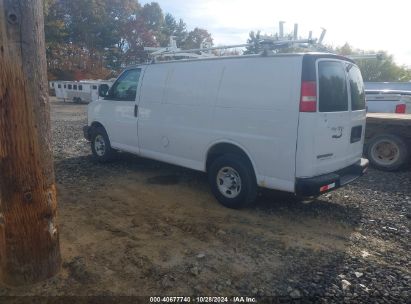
[[139, 61, 223, 170]]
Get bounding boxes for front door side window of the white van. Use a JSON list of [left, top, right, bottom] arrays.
[[105, 69, 141, 101]]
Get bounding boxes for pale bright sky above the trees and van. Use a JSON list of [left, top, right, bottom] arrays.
[[139, 0, 411, 66]]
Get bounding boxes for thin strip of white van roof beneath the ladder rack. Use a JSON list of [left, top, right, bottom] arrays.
[[126, 52, 355, 70]]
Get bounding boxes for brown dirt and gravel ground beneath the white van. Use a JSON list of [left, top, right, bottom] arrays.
[[0, 102, 411, 303]]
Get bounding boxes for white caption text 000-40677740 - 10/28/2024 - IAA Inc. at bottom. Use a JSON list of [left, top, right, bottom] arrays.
[[150, 297, 257, 303]]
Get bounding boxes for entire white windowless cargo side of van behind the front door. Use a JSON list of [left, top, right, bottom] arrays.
[[139, 56, 302, 191]]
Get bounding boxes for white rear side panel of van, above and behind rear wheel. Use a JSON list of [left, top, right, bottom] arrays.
[[212, 56, 302, 191]]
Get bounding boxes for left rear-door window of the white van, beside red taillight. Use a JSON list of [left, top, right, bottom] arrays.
[[318, 61, 348, 112]]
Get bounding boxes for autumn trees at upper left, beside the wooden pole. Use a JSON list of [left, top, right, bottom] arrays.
[[44, 0, 213, 80]]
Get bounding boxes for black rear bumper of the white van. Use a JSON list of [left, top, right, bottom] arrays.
[[295, 158, 369, 197]]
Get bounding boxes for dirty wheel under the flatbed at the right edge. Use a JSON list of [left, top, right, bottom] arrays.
[[367, 134, 409, 171]]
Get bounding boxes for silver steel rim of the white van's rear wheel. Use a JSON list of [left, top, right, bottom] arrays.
[[216, 167, 242, 198]]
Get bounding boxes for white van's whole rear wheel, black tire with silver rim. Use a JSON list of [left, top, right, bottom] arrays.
[[208, 154, 258, 209]]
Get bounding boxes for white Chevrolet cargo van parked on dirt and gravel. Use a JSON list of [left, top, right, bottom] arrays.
[[84, 53, 368, 208]]
